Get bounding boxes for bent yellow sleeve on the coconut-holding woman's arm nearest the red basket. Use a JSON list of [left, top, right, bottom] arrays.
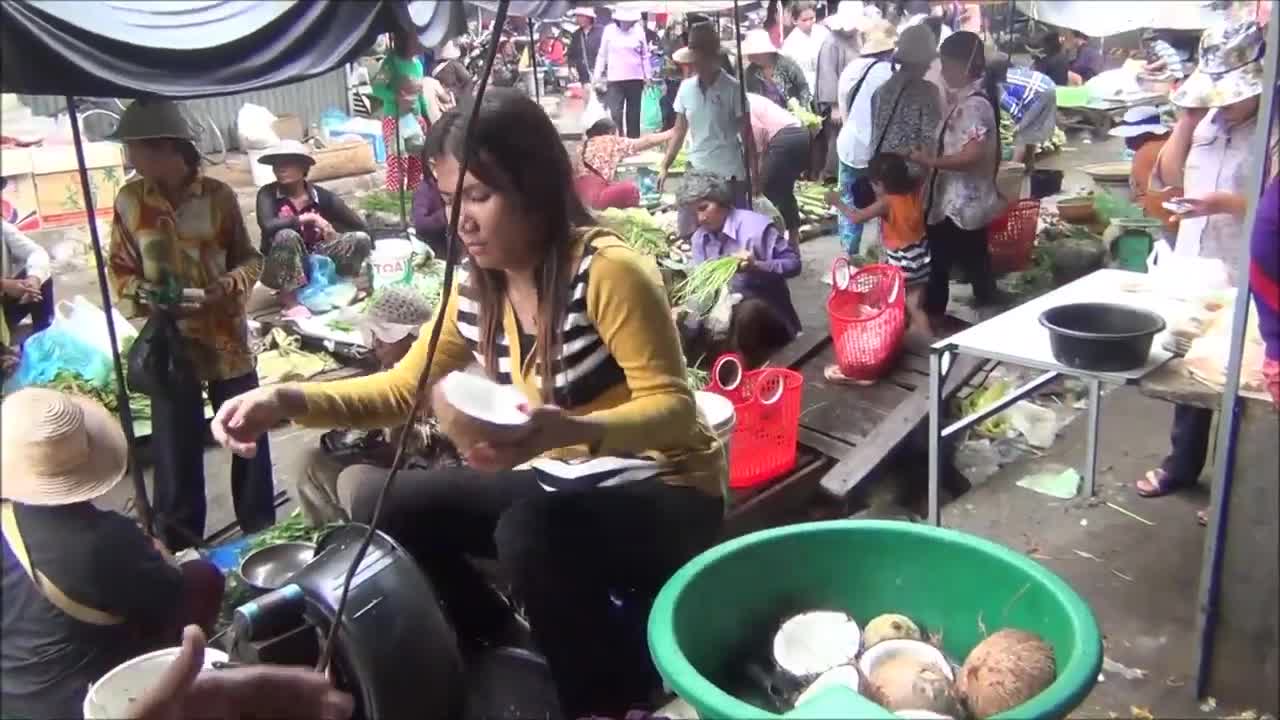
[[586, 245, 698, 455]]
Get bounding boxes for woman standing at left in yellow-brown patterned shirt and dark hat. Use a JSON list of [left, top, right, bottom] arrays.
[[108, 100, 275, 550]]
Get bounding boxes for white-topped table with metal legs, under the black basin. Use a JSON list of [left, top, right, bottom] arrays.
[[929, 269, 1190, 525]]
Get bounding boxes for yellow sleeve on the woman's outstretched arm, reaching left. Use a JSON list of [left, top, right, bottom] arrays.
[[294, 284, 471, 429]]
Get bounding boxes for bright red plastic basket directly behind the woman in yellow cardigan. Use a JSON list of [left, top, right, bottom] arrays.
[[707, 352, 804, 489]]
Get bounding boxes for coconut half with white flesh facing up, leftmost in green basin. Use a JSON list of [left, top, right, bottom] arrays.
[[773, 610, 863, 678]]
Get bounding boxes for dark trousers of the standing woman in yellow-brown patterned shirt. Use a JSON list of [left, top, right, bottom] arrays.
[[151, 373, 275, 543]]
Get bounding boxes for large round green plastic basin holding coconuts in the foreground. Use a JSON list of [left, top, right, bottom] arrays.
[[649, 520, 1102, 720]]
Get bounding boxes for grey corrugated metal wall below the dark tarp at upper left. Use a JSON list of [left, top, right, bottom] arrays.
[[22, 68, 347, 147]]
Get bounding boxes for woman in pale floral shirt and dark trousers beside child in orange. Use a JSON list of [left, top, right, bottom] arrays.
[[913, 32, 1004, 319]]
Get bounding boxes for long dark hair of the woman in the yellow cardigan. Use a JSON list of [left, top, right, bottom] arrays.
[[425, 87, 595, 402]]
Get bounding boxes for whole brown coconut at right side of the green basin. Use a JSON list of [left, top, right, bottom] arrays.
[[956, 629, 1057, 720]]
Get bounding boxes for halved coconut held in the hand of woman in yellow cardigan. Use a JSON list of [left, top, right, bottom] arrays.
[[431, 372, 529, 452]]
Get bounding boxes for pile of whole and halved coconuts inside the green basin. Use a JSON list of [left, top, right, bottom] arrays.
[[748, 610, 1057, 720]]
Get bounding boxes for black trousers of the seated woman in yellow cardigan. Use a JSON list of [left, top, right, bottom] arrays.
[[338, 466, 722, 717]]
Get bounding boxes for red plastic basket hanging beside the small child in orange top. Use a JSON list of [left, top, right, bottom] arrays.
[[827, 258, 906, 380]]
